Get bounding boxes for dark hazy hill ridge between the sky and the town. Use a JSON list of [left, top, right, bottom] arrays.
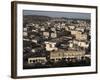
[[23, 15, 90, 24]]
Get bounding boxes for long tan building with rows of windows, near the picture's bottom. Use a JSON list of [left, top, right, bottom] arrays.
[[50, 50, 85, 62]]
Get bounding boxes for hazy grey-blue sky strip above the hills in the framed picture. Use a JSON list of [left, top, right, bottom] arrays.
[[23, 10, 91, 19]]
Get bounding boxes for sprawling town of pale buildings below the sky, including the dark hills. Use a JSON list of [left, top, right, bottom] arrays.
[[23, 13, 91, 69]]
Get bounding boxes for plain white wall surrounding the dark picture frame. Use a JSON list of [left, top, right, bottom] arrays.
[[0, 0, 100, 80]]
